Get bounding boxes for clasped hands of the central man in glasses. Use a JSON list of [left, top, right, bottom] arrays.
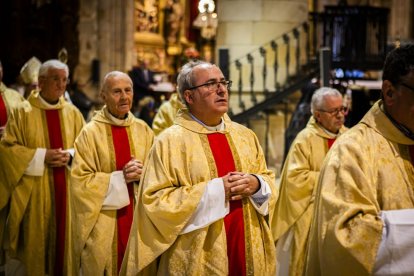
[[222, 172, 260, 200]]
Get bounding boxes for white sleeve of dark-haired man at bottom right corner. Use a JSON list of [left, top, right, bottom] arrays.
[[373, 209, 414, 275]]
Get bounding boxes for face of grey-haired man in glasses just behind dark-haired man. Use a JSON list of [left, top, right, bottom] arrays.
[[314, 96, 345, 133]]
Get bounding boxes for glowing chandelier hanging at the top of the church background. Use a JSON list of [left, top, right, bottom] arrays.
[[193, 0, 218, 39]]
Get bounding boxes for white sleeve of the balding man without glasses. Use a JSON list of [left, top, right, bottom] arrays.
[[102, 171, 129, 210]]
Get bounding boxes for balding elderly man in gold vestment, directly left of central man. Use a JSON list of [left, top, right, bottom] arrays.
[[70, 71, 154, 276]]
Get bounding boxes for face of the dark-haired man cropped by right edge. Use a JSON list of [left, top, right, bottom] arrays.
[[384, 70, 414, 132]]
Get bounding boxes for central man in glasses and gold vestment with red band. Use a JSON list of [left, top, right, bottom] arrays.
[[121, 61, 277, 275]]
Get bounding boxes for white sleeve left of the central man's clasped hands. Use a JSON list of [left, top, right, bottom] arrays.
[[180, 178, 230, 235]]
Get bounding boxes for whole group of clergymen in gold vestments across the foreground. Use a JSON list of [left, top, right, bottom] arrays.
[[0, 44, 414, 275]]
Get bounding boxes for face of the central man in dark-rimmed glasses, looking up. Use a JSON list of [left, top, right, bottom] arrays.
[[185, 66, 229, 125]]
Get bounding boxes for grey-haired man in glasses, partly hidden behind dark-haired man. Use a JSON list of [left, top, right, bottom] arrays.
[[271, 87, 346, 275]]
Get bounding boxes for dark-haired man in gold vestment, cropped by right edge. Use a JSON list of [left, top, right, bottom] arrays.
[[306, 44, 414, 275]]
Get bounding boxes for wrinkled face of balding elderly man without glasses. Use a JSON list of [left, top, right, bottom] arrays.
[[102, 76, 134, 119]]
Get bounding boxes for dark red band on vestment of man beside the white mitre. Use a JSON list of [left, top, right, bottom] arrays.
[[45, 109, 66, 275]]
